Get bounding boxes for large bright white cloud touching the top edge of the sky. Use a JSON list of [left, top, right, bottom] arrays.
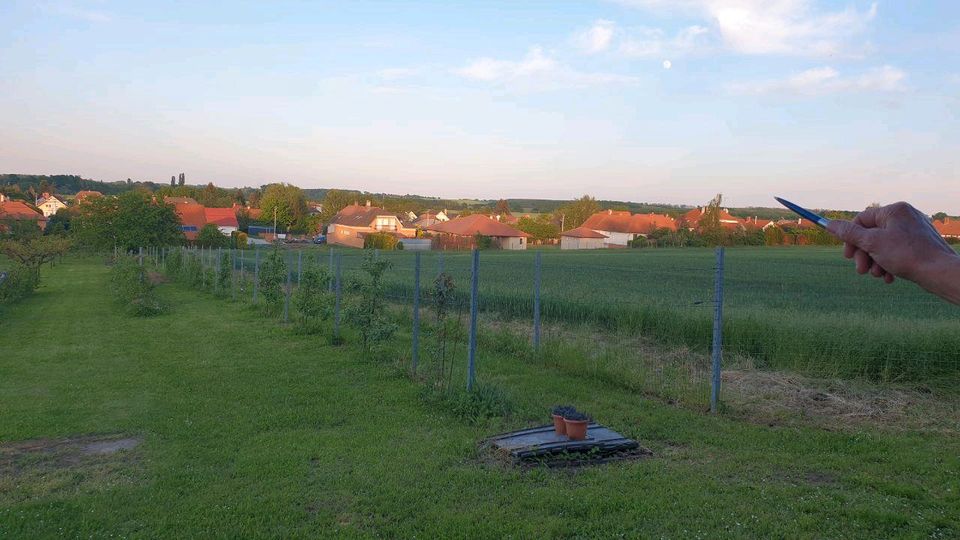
[[615, 0, 877, 56]]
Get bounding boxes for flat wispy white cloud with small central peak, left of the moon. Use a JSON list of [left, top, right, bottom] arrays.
[[453, 46, 639, 90]]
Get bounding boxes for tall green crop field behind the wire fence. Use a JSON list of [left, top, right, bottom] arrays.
[[262, 247, 960, 380]]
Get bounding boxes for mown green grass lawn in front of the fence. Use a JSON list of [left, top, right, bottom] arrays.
[[0, 259, 960, 538]]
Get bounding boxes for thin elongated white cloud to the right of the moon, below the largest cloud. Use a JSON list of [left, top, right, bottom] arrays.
[[727, 66, 907, 96]]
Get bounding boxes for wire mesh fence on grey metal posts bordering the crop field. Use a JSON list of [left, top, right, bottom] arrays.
[[147, 247, 960, 414]]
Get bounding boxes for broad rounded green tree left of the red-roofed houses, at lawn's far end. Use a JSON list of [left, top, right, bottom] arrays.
[[72, 191, 183, 250]]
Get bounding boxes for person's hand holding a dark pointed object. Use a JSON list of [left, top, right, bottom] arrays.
[[827, 202, 960, 297]]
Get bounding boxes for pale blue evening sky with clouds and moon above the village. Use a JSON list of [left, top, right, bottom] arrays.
[[0, 0, 960, 215]]
